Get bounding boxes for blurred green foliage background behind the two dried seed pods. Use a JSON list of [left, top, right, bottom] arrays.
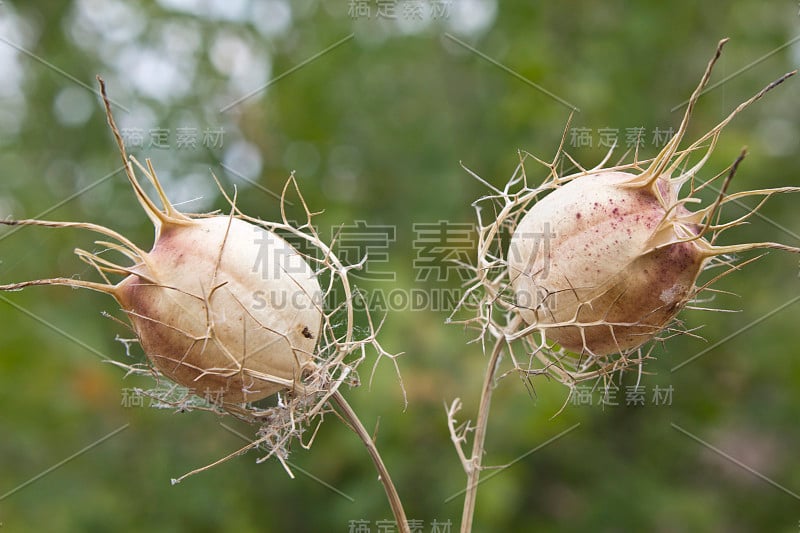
[[0, 0, 800, 532]]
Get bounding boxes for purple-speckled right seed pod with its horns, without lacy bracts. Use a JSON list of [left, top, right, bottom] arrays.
[[507, 86, 800, 356]]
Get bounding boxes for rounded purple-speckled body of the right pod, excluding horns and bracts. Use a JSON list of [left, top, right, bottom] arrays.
[[508, 171, 704, 355]]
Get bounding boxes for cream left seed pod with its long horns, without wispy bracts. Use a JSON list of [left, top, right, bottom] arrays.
[[0, 80, 323, 405]]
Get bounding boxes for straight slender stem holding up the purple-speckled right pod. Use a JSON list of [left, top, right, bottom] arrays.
[[461, 336, 506, 533]]
